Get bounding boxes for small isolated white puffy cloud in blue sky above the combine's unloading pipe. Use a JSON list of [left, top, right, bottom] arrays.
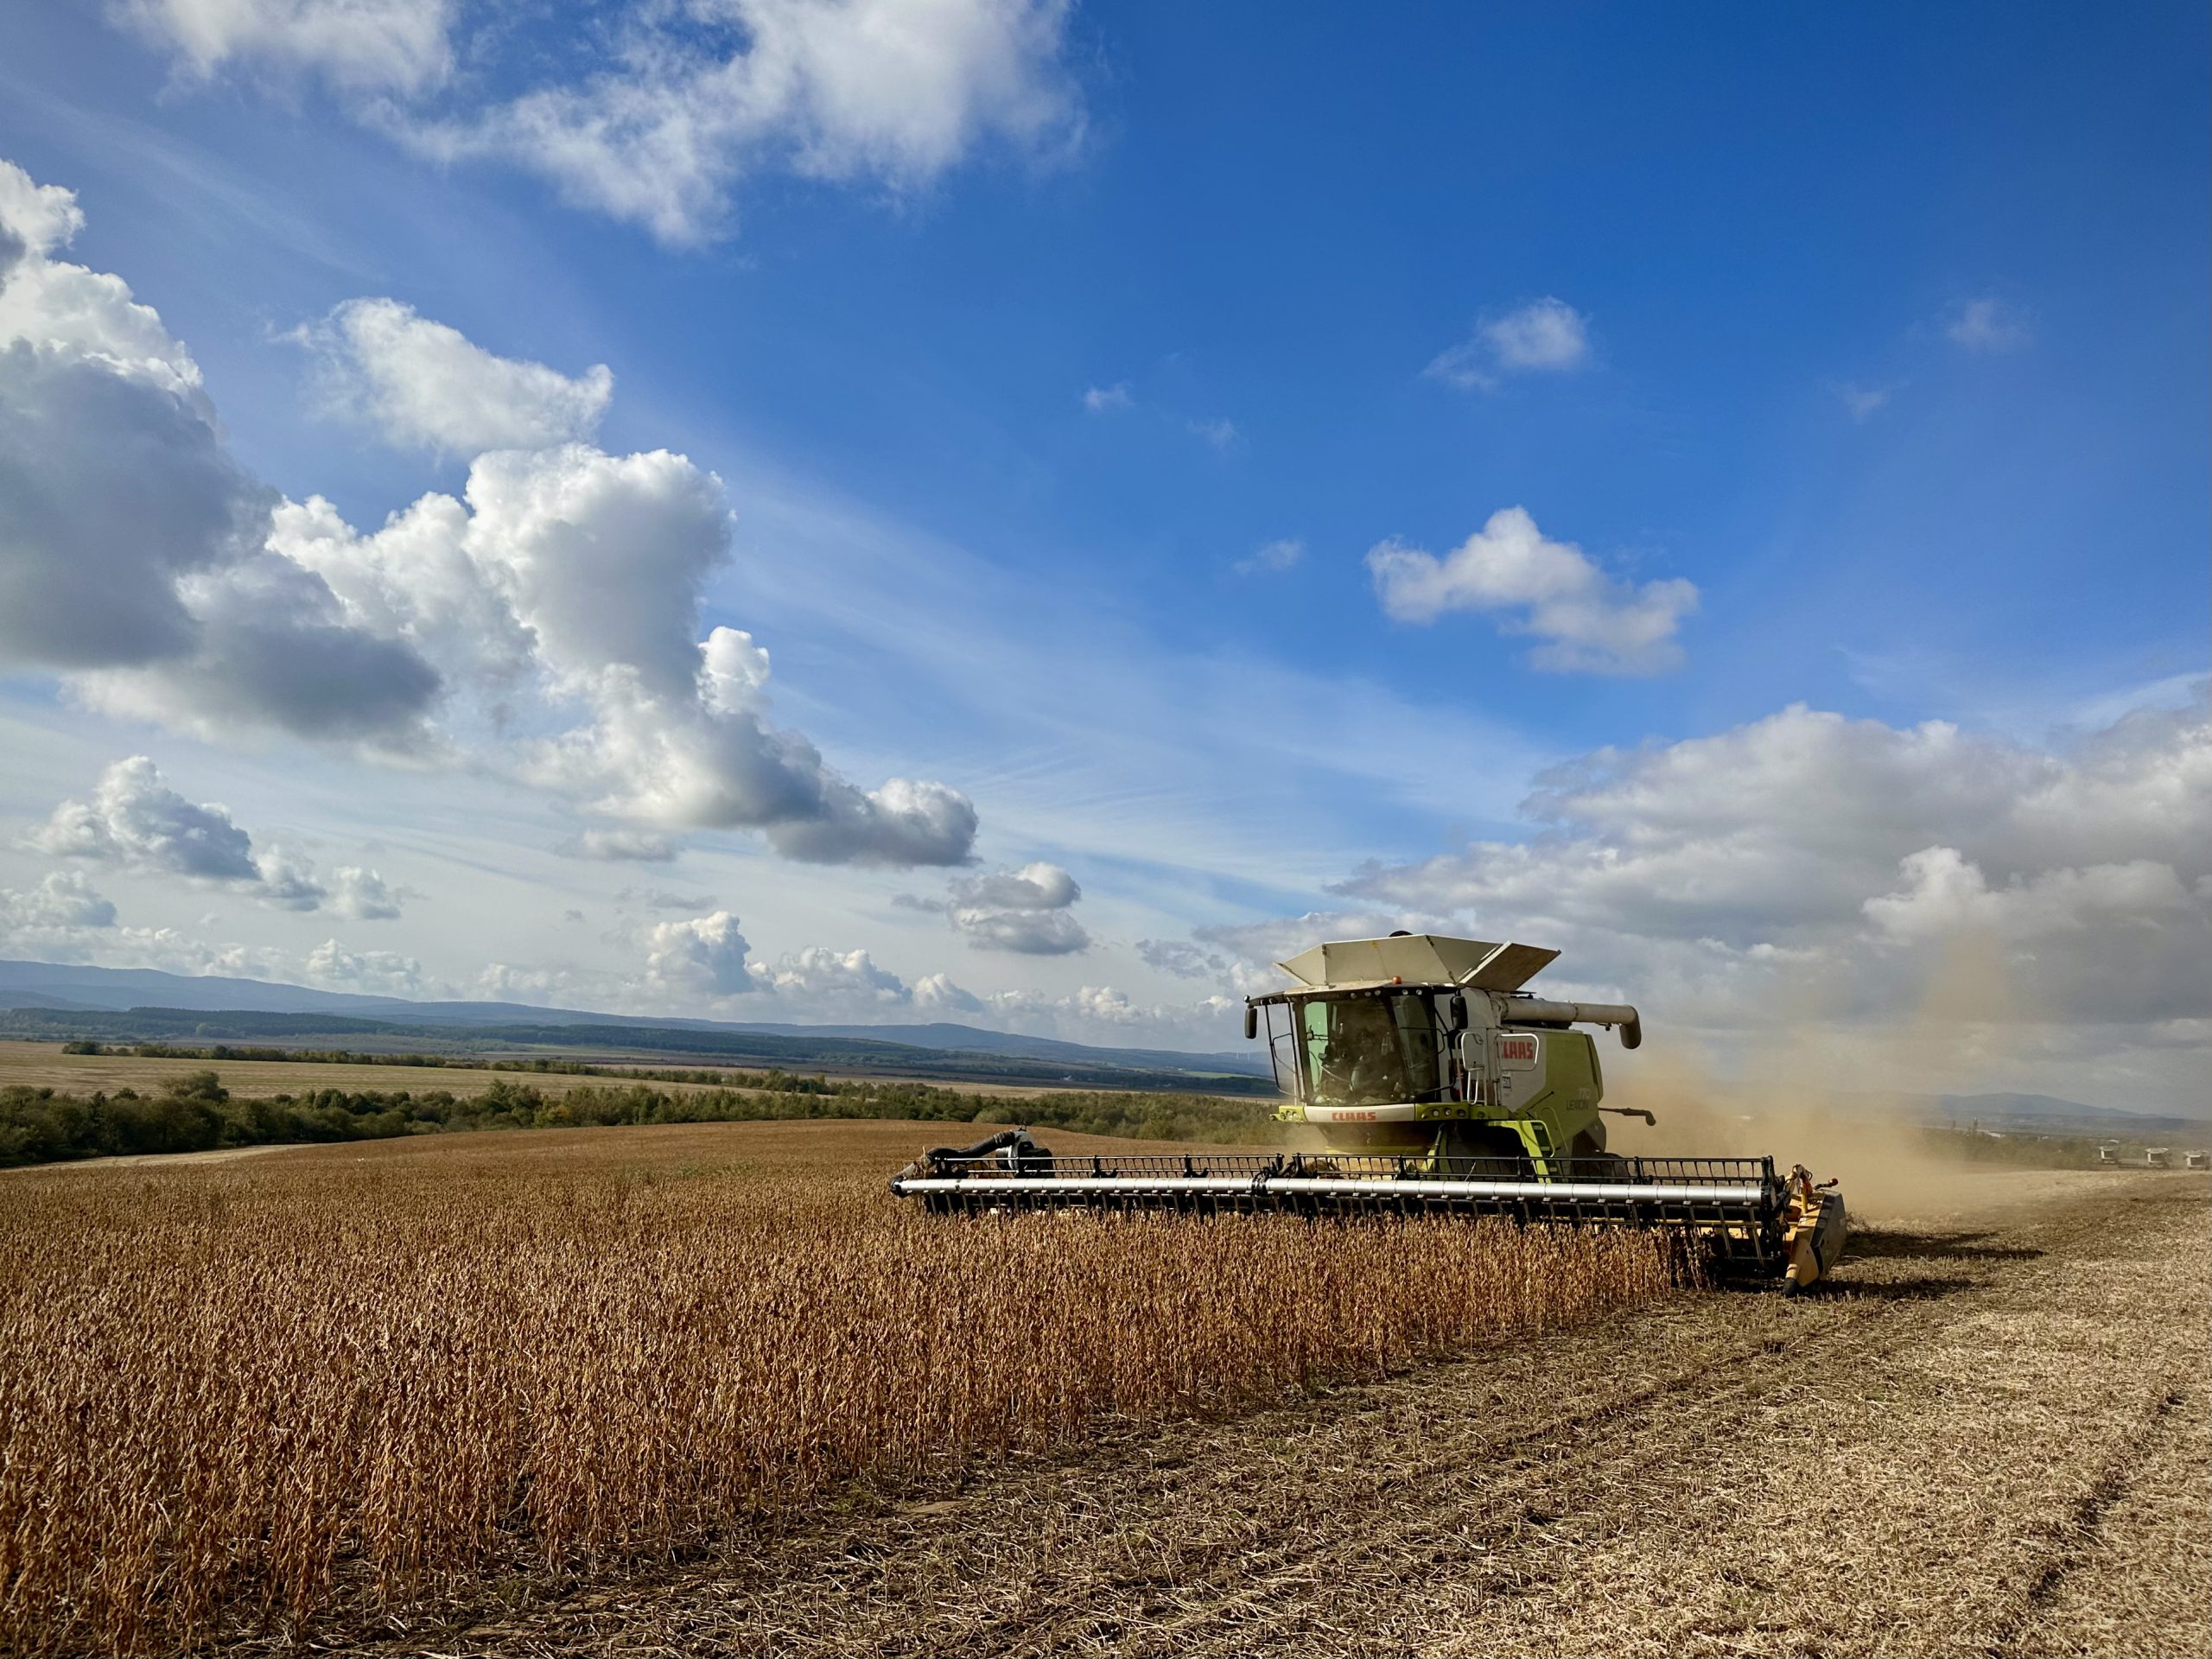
[[1367, 506, 1697, 675]]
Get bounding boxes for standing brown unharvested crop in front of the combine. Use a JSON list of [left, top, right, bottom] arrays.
[[0, 1126, 1681, 1650]]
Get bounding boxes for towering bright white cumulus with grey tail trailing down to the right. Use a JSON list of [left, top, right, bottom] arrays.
[[279, 445, 976, 865]]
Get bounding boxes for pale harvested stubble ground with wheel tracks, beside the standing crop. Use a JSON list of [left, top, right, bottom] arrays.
[[435, 1174, 2212, 1659]]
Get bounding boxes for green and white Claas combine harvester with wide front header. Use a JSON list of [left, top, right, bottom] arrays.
[[892, 933, 1847, 1292]]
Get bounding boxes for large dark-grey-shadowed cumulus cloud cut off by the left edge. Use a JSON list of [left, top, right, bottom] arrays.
[[0, 162, 438, 746]]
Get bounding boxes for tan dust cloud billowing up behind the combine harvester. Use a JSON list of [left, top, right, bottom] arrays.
[[1606, 931, 2033, 1221]]
